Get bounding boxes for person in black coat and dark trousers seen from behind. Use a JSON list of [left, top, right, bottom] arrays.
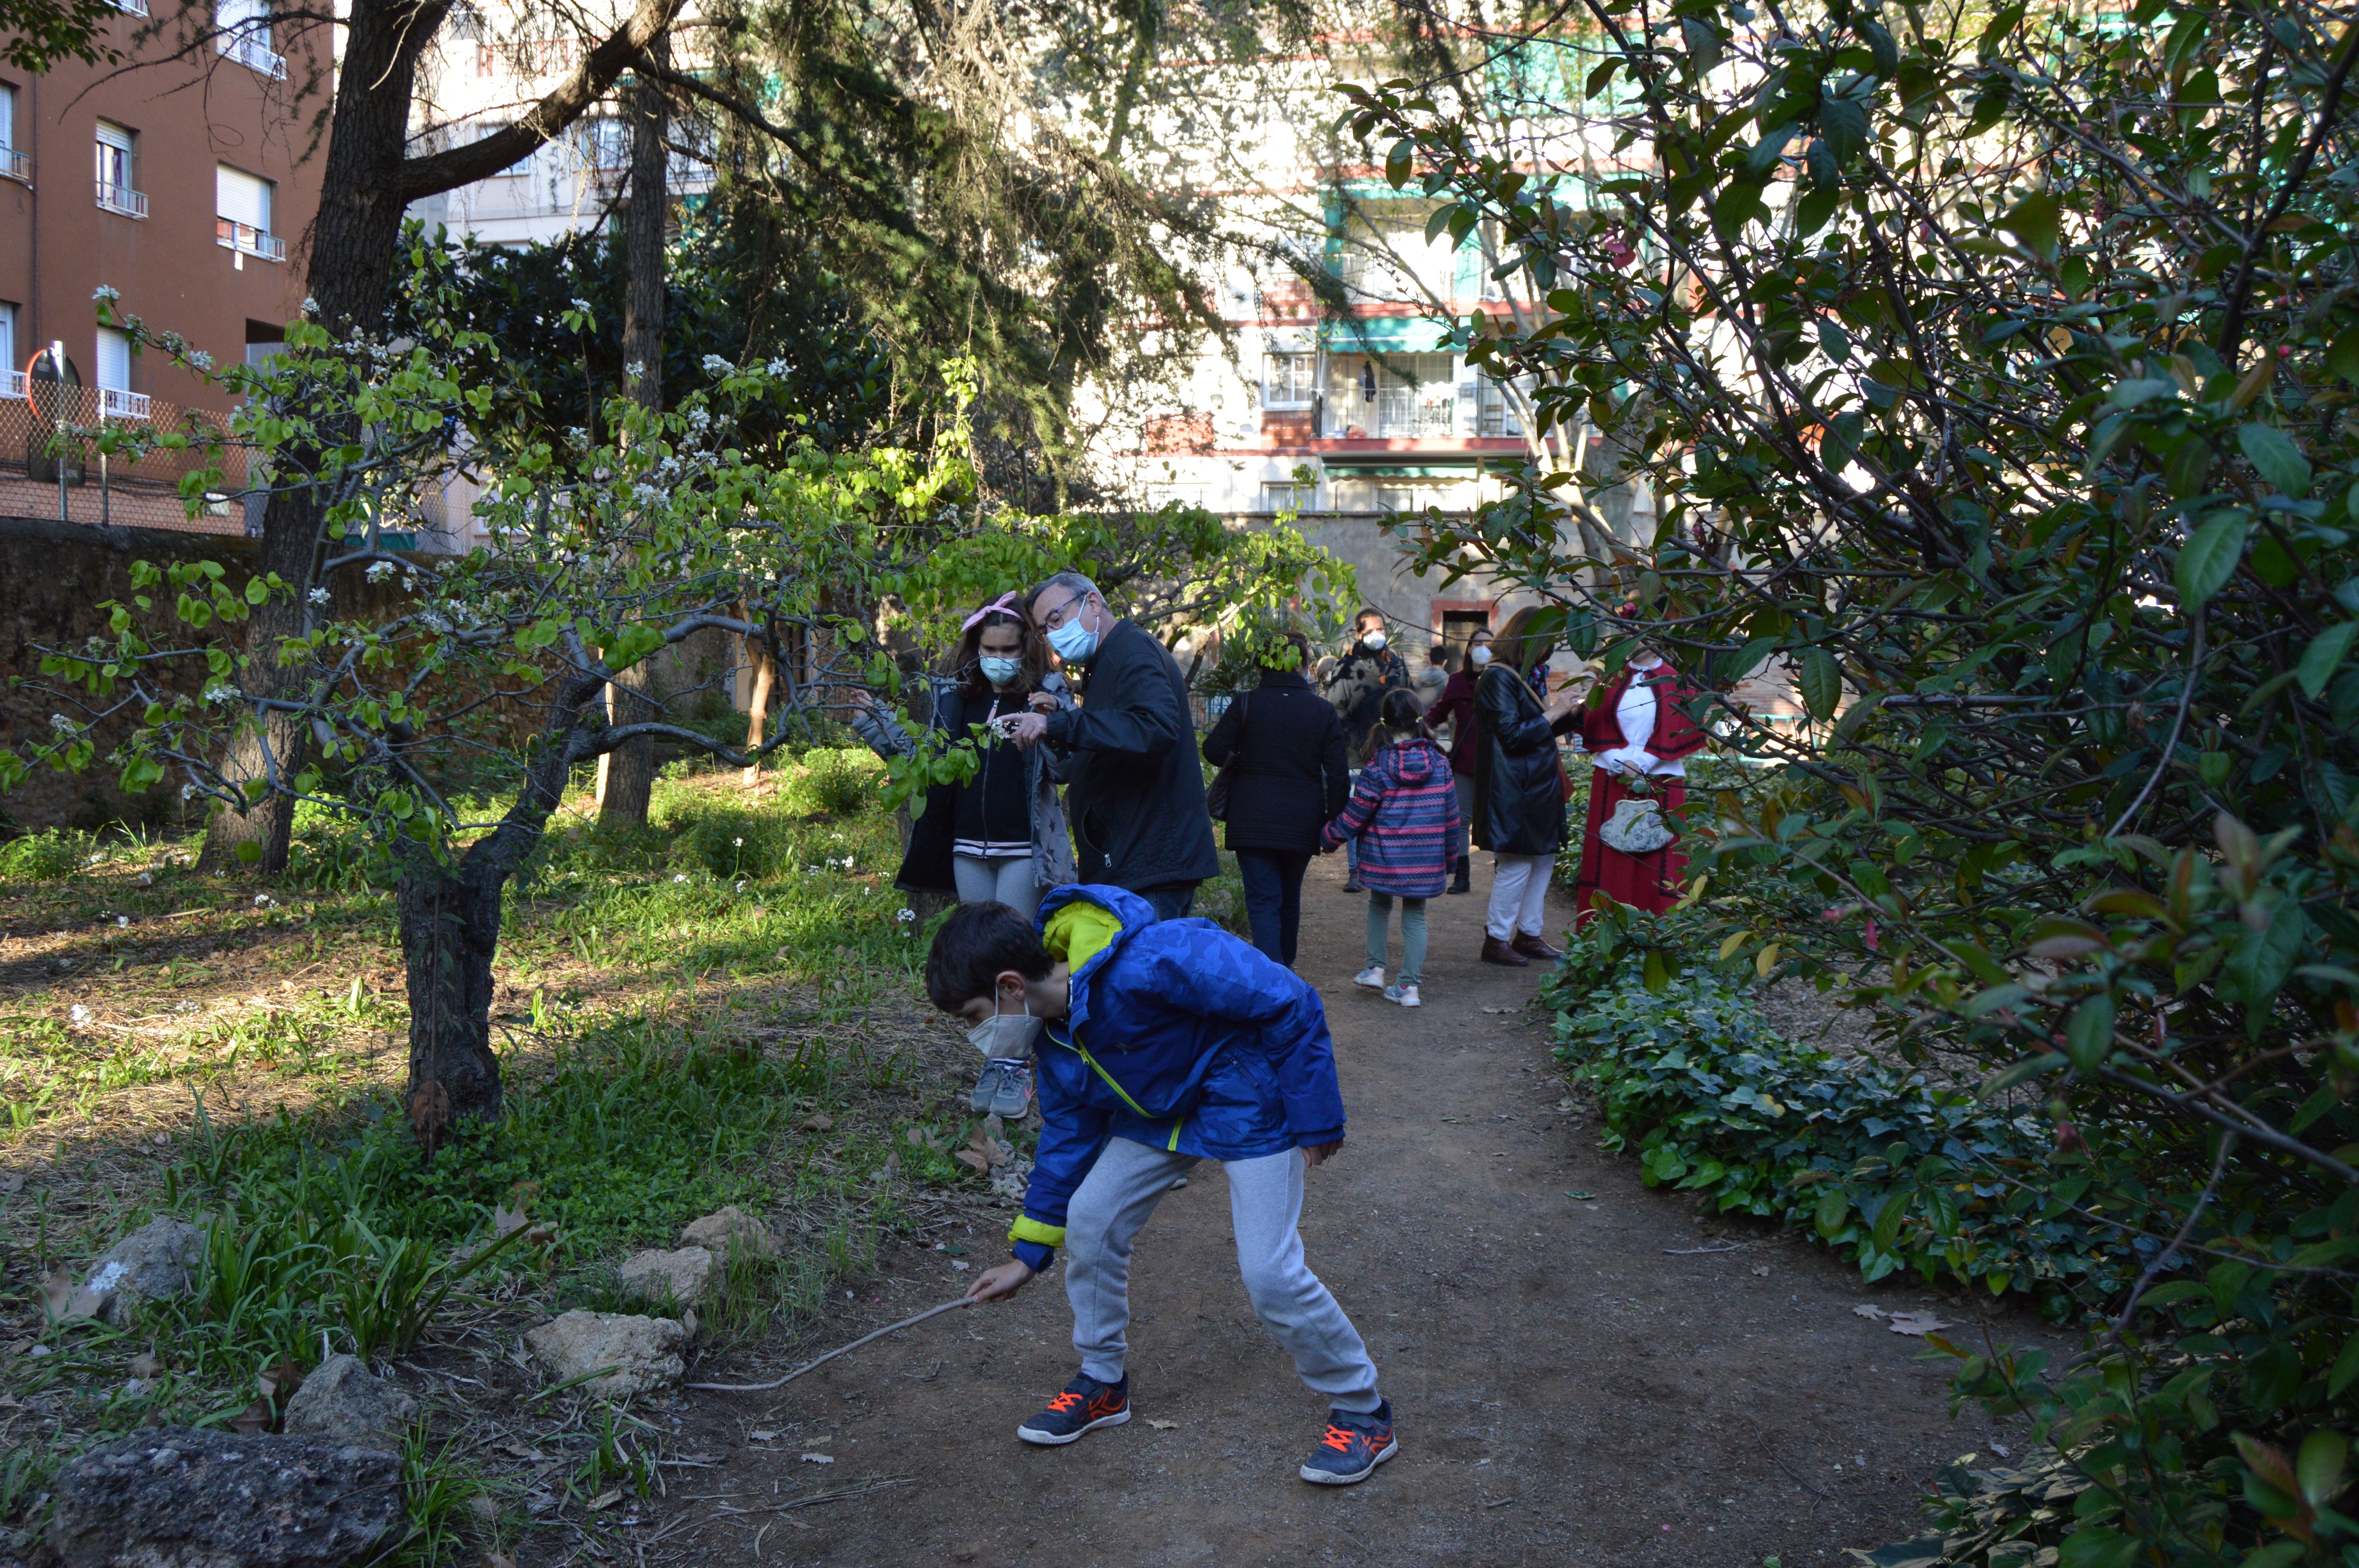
[[1203, 632, 1352, 969]]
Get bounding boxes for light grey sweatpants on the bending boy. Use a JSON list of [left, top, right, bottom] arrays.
[[1064, 1139, 1382, 1415]]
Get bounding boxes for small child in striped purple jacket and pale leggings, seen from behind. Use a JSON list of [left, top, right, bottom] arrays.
[[1321, 691, 1458, 1007]]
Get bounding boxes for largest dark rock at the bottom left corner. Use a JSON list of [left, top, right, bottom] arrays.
[[49, 1426, 401, 1568]]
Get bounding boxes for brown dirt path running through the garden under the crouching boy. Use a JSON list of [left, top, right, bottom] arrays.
[[660, 856, 2028, 1568]]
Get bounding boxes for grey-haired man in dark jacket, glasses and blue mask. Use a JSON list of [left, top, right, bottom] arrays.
[[1012, 571, 1219, 920]]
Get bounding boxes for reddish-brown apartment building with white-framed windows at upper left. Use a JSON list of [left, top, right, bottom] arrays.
[[0, 0, 318, 533]]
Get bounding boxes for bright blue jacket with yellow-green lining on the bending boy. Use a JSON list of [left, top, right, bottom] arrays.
[[1007, 884, 1342, 1269]]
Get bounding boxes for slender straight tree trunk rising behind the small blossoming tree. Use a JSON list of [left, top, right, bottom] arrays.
[[597, 40, 670, 828]]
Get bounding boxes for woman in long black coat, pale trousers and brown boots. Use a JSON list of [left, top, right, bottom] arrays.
[[1474, 608, 1581, 969]]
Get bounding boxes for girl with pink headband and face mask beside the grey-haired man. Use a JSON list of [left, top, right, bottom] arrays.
[[852, 594, 1076, 1118]]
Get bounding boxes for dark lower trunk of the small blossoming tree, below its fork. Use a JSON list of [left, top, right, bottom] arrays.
[[399, 853, 507, 1158]]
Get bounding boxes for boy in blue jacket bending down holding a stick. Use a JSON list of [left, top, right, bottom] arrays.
[[925, 887, 1399, 1485]]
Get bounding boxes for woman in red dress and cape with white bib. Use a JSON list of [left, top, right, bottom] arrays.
[[1574, 632, 1703, 929]]
